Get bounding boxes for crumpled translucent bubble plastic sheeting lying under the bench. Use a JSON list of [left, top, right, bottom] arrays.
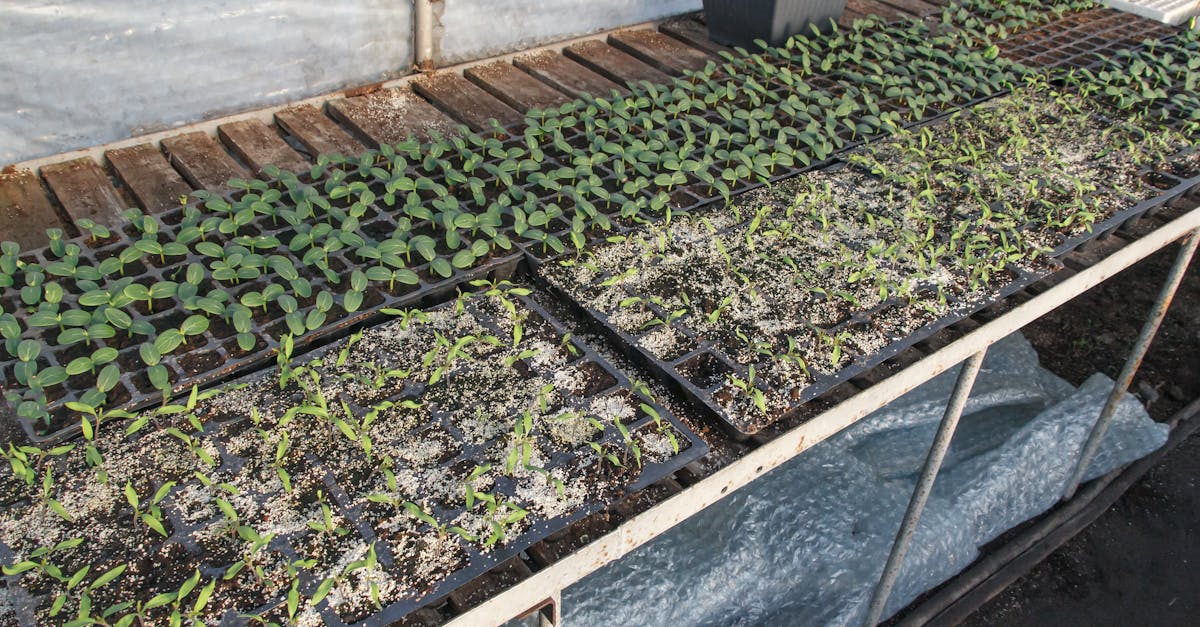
[[563, 335, 1168, 626]]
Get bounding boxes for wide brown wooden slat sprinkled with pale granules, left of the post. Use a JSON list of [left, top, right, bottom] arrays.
[[329, 88, 458, 147]]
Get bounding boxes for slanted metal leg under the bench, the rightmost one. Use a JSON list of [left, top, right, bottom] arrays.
[[1062, 229, 1200, 501]]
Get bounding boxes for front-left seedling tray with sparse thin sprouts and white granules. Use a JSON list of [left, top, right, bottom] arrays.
[[0, 282, 707, 626]]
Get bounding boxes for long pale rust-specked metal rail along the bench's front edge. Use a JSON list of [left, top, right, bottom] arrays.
[[449, 202, 1200, 627]]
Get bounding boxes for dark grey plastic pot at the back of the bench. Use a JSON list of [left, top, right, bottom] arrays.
[[704, 0, 846, 48]]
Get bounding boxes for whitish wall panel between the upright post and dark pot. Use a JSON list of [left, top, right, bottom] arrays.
[[434, 0, 701, 65]]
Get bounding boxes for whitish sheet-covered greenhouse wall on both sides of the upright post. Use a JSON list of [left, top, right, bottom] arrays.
[[0, 0, 701, 165]]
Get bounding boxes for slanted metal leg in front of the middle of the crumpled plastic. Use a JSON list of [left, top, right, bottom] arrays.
[[863, 347, 988, 627]]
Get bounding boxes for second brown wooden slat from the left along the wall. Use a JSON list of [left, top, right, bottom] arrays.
[[42, 157, 130, 226]]
